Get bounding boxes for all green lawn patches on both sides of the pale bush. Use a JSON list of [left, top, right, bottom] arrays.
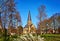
[[0, 34, 60, 41]]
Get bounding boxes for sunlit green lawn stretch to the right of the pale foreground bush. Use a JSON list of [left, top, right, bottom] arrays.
[[41, 34, 60, 41]]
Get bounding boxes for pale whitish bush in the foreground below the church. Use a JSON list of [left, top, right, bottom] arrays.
[[17, 34, 44, 41]]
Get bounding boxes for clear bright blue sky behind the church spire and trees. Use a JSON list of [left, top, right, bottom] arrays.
[[16, 0, 60, 27]]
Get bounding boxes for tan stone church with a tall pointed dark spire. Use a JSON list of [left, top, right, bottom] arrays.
[[23, 11, 36, 34]]
